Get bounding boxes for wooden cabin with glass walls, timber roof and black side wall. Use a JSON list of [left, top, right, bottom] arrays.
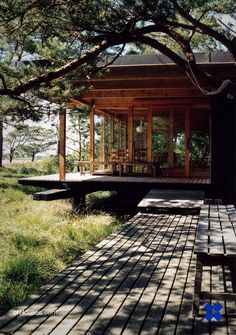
[[65, 53, 236, 202]]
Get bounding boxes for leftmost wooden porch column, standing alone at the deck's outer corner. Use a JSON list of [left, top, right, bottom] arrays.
[[59, 109, 66, 181]]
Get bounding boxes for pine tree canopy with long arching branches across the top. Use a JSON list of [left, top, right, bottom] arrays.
[[0, 0, 236, 119]]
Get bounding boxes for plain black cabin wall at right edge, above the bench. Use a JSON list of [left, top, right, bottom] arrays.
[[211, 94, 236, 202]]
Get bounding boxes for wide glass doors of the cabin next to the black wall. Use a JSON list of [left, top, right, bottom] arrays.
[[152, 107, 210, 177]]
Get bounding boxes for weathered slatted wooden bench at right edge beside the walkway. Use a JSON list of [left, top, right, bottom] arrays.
[[193, 205, 236, 316]]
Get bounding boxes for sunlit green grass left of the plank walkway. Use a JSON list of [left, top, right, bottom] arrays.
[[0, 164, 121, 313]]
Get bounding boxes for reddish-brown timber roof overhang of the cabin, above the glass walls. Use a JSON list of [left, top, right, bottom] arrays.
[[73, 54, 236, 112]]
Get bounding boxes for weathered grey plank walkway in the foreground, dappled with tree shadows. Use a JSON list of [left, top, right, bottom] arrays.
[[0, 213, 236, 335]]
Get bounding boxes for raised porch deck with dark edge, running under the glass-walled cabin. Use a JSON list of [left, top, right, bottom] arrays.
[[19, 173, 211, 194]]
